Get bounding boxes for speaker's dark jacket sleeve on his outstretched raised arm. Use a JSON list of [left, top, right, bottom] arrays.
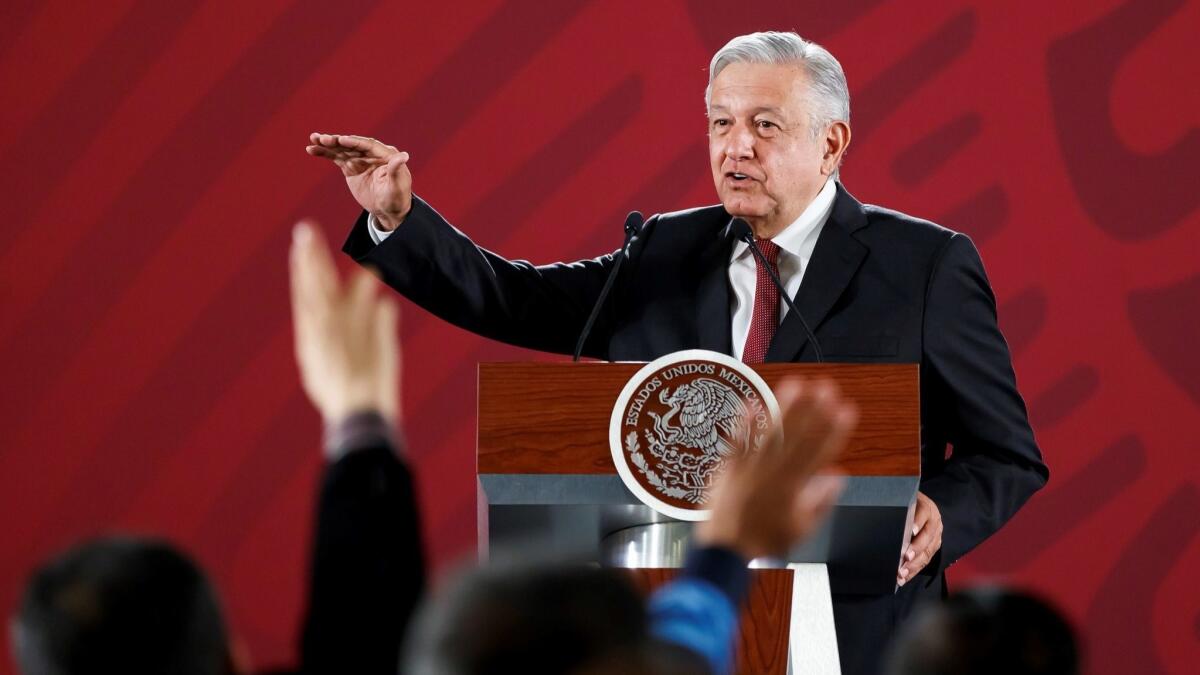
[[342, 196, 613, 358]]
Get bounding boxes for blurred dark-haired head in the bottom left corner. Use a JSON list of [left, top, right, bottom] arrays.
[[13, 537, 232, 675]]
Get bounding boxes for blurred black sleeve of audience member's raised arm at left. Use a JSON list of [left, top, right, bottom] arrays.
[[300, 442, 425, 675]]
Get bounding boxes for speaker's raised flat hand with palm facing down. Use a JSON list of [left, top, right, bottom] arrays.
[[305, 133, 413, 232]]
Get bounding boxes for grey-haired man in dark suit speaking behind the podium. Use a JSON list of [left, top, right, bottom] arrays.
[[307, 32, 1049, 674]]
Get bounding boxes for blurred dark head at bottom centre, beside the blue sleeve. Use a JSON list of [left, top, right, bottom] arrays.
[[403, 563, 707, 675]]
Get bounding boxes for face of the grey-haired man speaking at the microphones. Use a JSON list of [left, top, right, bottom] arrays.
[[708, 64, 828, 237]]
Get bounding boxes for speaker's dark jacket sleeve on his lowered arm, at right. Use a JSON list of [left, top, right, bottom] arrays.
[[920, 234, 1049, 573]]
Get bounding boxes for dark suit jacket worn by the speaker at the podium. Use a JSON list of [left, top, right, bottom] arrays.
[[344, 184, 1048, 674]]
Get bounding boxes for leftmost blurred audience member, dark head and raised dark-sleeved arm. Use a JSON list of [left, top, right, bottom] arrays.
[[13, 225, 425, 675]]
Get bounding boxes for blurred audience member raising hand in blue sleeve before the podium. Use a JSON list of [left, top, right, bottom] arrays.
[[404, 381, 856, 675]]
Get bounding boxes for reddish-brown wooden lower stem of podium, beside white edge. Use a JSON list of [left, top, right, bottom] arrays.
[[628, 568, 792, 675]]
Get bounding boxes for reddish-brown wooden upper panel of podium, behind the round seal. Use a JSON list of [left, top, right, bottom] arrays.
[[478, 363, 920, 476]]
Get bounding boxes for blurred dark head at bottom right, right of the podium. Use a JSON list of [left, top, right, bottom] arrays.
[[888, 589, 1080, 675]]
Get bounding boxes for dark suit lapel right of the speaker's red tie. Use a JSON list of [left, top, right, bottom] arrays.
[[767, 183, 869, 362]]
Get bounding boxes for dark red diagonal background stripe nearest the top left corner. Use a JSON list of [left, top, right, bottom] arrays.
[[0, 0, 373, 439]]
